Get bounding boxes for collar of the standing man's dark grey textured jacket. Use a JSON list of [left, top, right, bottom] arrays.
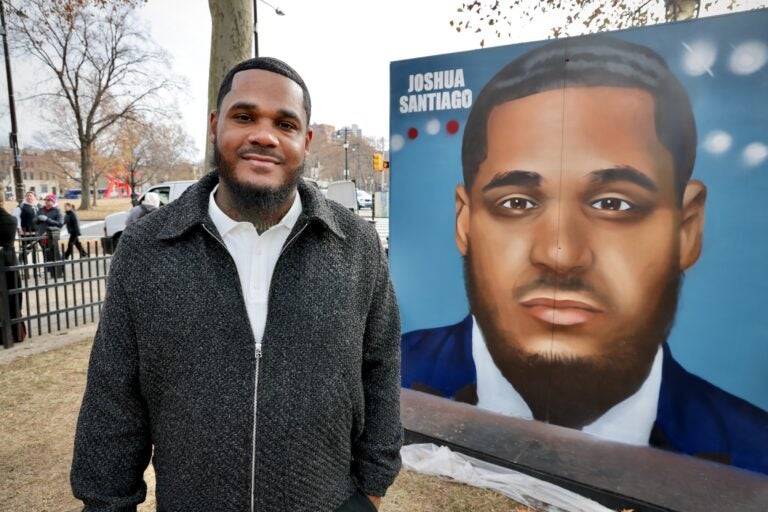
[[158, 170, 346, 240]]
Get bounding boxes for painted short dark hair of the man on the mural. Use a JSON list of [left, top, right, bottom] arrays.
[[461, 35, 696, 198]]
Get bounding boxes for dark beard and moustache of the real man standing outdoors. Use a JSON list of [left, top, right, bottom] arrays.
[[213, 143, 304, 219]]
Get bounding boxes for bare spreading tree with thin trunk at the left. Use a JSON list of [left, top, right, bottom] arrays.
[[8, 0, 177, 209]]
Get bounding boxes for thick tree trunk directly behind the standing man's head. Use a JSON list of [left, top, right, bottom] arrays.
[[205, 0, 253, 163]]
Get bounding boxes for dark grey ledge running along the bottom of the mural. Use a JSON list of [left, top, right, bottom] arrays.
[[400, 389, 768, 512]]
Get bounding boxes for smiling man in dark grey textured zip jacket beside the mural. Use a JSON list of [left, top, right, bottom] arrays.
[[71, 58, 402, 512]]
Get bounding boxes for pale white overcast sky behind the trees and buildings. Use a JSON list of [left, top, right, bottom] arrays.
[[0, 0, 560, 158]]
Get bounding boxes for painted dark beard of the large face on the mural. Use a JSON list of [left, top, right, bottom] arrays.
[[464, 248, 683, 429]]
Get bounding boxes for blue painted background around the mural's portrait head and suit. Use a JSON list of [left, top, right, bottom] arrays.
[[390, 10, 768, 410]]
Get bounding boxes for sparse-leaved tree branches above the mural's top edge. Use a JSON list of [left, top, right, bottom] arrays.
[[450, 0, 768, 47]]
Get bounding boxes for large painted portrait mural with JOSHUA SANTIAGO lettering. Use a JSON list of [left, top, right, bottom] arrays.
[[390, 10, 768, 473]]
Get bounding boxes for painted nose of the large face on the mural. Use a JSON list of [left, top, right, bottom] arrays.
[[531, 207, 594, 275]]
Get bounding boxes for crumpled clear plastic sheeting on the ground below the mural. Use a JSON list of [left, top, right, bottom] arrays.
[[400, 443, 611, 512]]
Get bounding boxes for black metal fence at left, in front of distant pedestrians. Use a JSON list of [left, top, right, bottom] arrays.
[[0, 229, 112, 348]]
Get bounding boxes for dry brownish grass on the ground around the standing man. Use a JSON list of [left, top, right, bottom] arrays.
[[0, 338, 530, 512]]
